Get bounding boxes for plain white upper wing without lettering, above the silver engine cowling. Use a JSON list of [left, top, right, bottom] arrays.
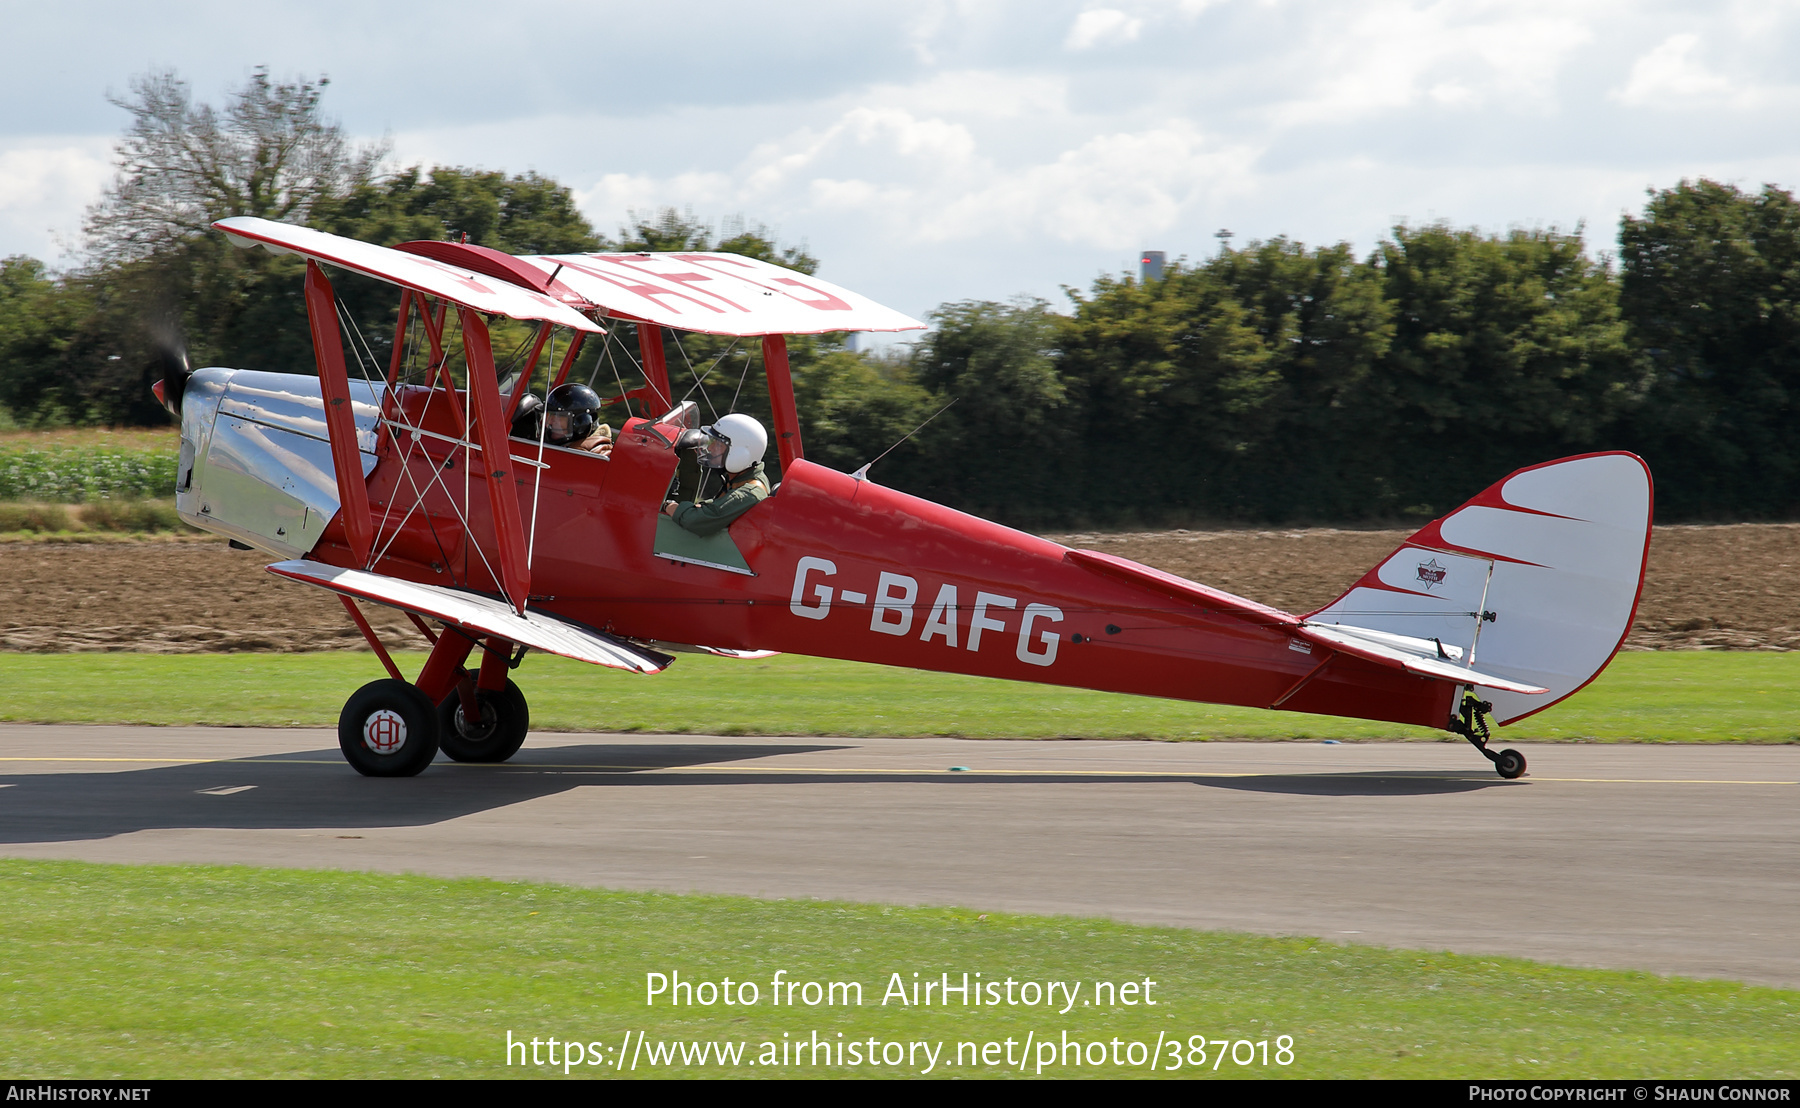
[[212, 216, 605, 335]]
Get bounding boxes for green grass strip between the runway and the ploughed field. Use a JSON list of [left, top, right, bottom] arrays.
[[0, 651, 1800, 743]]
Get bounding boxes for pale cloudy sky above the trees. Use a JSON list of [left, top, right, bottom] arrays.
[[0, 0, 1800, 323]]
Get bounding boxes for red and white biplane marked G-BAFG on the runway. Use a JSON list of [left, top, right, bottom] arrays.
[[157, 218, 1651, 777]]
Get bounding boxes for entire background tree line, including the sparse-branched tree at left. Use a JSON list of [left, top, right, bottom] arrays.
[[0, 70, 1800, 527]]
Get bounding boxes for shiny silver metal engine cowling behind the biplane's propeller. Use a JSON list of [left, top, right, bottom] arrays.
[[175, 367, 385, 558]]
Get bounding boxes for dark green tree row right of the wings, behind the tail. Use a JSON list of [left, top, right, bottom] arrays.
[[824, 180, 1800, 527]]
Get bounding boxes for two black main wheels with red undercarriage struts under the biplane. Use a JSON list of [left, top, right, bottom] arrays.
[[338, 631, 531, 777]]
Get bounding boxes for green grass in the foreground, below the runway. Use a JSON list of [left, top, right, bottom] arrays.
[[0, 862, 1800, 1079]]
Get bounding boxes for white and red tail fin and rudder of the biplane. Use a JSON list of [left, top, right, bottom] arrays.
[[1307, 453, 1652, 723]]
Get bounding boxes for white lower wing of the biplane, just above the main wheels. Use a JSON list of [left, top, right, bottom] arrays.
[[268, 559, 673, 673]]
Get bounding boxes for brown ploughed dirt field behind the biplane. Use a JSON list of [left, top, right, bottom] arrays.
[[0, 523, 1800, 653]]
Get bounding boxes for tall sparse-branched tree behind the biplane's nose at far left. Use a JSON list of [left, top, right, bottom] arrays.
[[52, 68, 385, 423]]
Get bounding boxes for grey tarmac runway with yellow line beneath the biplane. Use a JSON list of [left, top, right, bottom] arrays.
[[0, 725, 1800, 987]]
